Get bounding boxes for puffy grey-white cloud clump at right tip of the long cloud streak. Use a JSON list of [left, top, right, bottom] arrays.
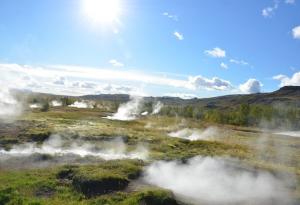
[[189, 75, 233, 90]]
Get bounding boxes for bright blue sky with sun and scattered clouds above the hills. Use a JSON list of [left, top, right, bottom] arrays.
[[0, 0, 300, 98]]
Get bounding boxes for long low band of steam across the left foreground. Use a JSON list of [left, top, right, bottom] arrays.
[[0, 135, 148, 160]]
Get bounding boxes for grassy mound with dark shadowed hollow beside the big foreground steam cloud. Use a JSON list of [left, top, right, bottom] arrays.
[[57, 160, 142, 197]]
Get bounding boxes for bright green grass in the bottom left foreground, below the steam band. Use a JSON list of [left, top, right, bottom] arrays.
[[0, 160, 175, 205]]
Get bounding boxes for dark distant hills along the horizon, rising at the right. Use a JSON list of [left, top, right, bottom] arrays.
[[19, 86, 300, 109]]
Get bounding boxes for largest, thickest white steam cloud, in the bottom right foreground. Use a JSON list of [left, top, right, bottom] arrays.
[[145, 157, 290, 205]]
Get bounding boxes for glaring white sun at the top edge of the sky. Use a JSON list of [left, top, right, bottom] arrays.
[[82, 0, 121, 24]]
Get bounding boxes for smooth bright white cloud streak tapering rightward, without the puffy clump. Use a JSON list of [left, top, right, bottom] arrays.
[[0, 64, 191, 91]]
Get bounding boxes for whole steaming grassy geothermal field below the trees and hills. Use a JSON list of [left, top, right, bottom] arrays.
[[0, 92, 300, 205]]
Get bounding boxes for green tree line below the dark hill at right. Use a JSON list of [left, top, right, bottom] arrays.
[[160, 104, 300, 128]]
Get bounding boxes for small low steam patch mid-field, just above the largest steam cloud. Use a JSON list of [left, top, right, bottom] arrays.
[[168, 127, 218, 141]]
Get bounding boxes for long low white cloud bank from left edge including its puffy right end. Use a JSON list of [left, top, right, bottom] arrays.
[[0, 64, 236, 95]]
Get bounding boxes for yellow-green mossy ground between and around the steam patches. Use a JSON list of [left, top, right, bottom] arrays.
[[0, 108, 300, 205]]
